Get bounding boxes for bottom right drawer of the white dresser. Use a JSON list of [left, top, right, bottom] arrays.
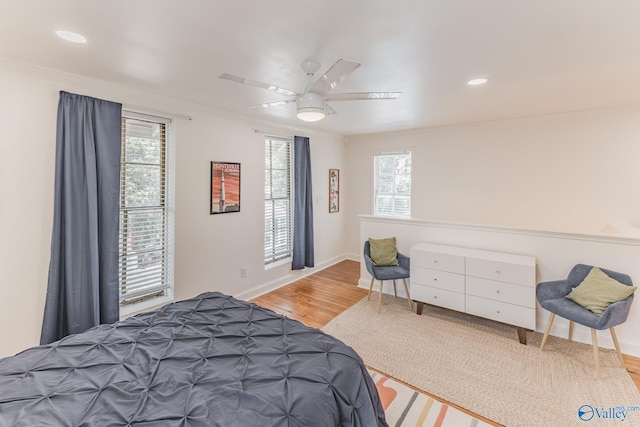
[[465, 295, 536, 330]]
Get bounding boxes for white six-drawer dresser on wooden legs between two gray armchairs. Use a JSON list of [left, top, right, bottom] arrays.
[[410, 243, 536, 344]]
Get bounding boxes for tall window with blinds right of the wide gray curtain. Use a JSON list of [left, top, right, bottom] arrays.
[[119, 112, 173, 308]]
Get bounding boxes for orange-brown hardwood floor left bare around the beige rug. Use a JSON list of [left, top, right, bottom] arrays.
[[252, 261, 640, 398]]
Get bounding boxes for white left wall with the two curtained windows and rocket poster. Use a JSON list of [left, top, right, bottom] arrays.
[[0, 60, 346, 357]]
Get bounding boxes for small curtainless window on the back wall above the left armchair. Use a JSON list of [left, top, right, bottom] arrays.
[[373, 152, 411, 218]]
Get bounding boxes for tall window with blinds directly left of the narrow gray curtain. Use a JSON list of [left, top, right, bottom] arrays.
[[264, 137, 293, 265]]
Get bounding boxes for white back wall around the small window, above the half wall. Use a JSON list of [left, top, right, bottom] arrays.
[[347, 106, 640, 258]]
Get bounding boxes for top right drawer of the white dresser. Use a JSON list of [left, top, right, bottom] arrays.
[[466, 258, 536, 287]]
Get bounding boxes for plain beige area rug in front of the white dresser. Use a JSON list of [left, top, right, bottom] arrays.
[[322, 295, 640, 427]]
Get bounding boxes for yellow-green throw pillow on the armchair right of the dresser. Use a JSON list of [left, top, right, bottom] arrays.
[[567, 267, 637, 316]]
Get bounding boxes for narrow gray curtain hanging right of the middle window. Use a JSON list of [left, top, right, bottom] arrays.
[[291, 136, 314, 270]]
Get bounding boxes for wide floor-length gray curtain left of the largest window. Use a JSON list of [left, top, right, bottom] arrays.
[[40, 92, 122, 344]]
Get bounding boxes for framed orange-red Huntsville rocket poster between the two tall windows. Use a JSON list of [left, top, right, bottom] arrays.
[[210, 162, 240, 215]]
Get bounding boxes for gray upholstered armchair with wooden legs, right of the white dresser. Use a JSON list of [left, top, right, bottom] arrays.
[[536, 264, 633, 374]]
